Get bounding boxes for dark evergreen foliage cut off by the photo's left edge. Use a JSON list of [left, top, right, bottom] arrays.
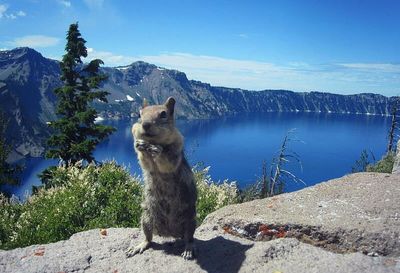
[[0, 111, 22, 186]]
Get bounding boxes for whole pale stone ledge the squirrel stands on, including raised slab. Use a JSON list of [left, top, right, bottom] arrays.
[[0, 173, 400, 273]]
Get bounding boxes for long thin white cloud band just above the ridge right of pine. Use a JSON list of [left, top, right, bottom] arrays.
[[88, 48, 400, 95]]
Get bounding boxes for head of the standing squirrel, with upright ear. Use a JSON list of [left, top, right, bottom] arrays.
[[136, 97, 175, 143]]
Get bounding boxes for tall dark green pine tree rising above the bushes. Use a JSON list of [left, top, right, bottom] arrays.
[[46, 23, 115, 165]]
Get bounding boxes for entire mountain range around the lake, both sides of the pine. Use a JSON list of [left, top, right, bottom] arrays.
[[0, 47, 395, 160]]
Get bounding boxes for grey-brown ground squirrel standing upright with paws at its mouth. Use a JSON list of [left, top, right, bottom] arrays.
[[127, 97, 197, 259]]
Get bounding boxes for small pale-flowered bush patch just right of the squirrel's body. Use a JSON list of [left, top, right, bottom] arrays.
[[194, 167, 239, 225]]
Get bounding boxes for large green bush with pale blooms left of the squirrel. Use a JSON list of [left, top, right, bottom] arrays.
[[0, 162, 142, 249]]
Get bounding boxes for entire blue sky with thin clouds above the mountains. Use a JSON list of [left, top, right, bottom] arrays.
[[0, 0, 400, 96]]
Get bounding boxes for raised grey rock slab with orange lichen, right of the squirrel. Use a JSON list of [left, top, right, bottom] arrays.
[[203, 173, 400, 257]]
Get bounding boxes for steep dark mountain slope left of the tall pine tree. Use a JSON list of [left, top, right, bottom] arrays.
[[0, 48, 61, 158]]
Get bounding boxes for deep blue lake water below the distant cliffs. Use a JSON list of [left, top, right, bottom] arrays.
[[3, 113, 390, 197]]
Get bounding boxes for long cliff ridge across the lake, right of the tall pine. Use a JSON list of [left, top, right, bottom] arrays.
[[101, 62, 393, 119]]
